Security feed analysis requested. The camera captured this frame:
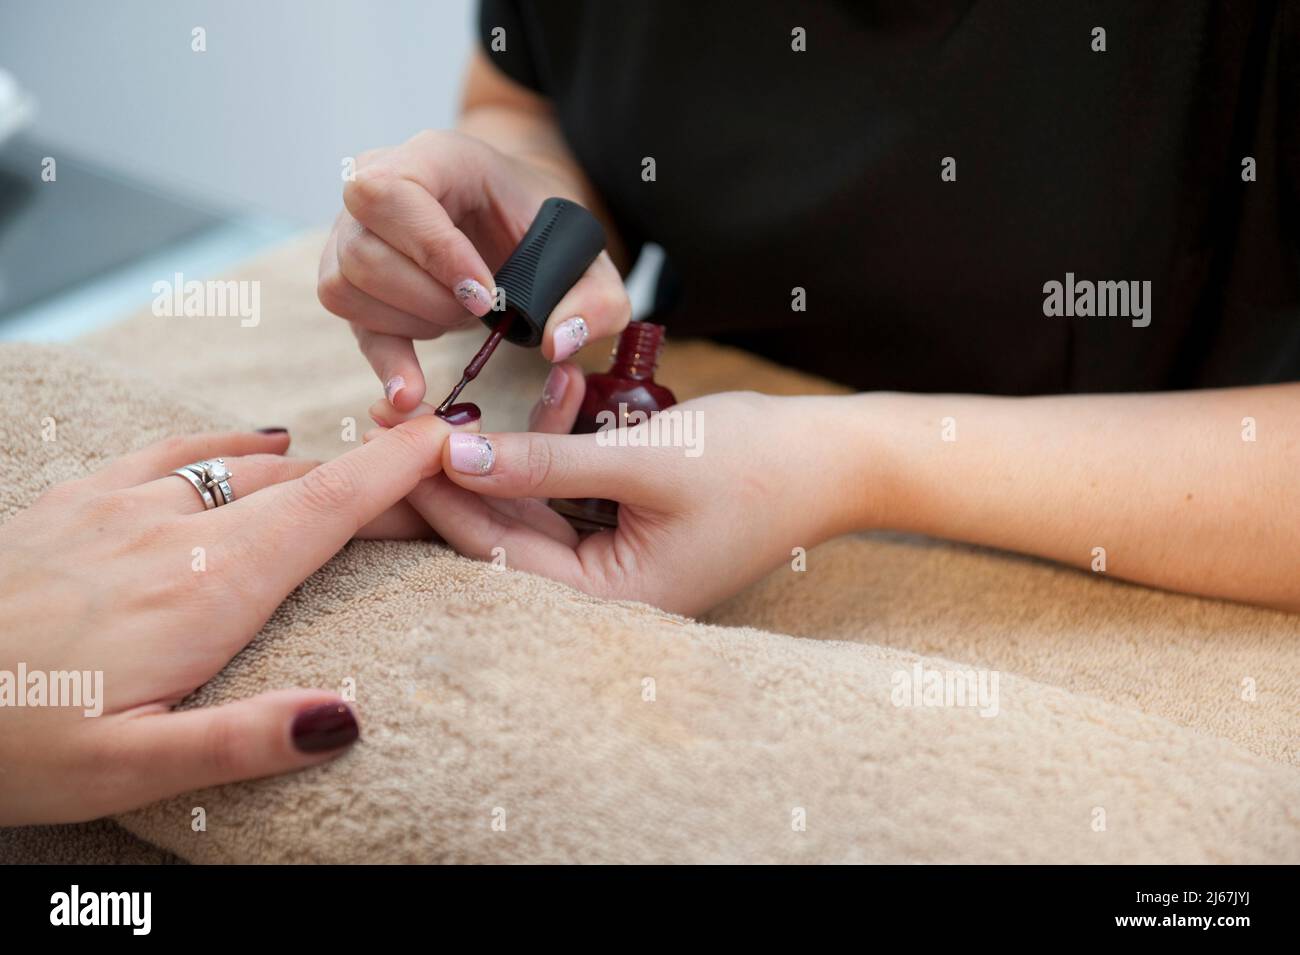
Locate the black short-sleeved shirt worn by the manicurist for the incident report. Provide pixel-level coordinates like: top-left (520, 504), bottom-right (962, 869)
top-left (480, 0), bottom-right (1300, 394)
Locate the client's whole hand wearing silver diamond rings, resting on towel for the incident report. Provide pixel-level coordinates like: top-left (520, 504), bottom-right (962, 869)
top-left (0, 417), bottom-right (467, 825)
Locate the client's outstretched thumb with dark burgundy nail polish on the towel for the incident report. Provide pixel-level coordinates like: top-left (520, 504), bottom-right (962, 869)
top-left (105, 690), bottom-right (360, 812)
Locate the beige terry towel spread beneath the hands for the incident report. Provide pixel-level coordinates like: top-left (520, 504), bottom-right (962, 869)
top-left (0, 238), bottom-right (1300, 863)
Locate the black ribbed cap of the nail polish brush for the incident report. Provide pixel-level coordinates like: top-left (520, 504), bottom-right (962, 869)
top-left (482, 199), bottom-right (605, 348)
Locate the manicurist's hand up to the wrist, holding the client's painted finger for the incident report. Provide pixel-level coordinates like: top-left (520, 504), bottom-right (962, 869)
top-left (384, 382), bottom-right (872, 613)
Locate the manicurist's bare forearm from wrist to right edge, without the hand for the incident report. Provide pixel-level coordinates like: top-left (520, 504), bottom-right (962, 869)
top-left (845, 385), bottom-right (1300, 609)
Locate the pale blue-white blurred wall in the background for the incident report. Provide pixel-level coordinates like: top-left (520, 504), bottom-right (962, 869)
top-left (0, 0), bottom-right (476, 225)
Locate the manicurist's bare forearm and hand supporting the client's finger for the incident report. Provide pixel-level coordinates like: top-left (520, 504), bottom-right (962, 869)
top-left (376, 365), bottom-right (1300, 613)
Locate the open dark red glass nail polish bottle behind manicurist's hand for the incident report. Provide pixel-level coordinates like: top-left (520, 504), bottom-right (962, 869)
top-left (551, 322), bottom-right (677, 531)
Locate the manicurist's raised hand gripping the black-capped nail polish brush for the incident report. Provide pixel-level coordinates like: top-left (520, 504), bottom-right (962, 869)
top-left (317, 55), bottom-right (632, 412)
